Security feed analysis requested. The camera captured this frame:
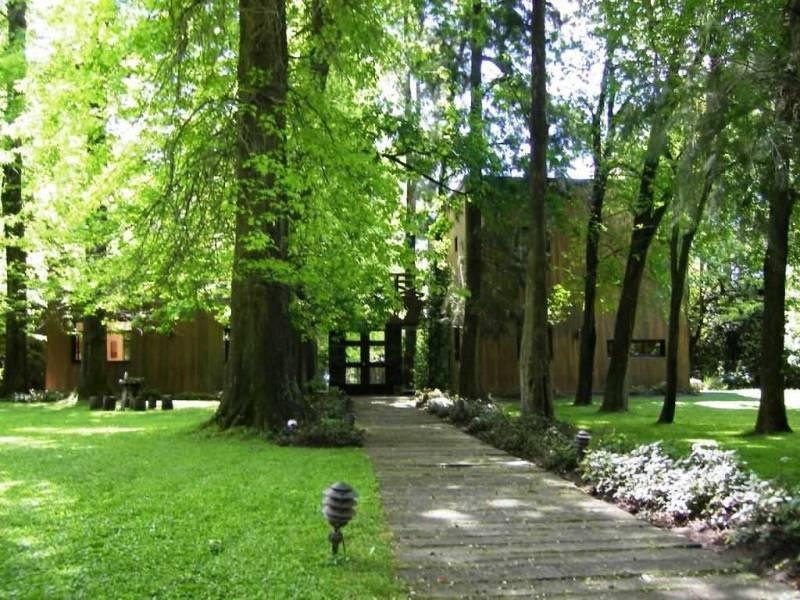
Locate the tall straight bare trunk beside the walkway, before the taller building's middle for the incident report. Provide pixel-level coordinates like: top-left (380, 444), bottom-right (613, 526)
top-left (520, 0), bottom-right (553, 418)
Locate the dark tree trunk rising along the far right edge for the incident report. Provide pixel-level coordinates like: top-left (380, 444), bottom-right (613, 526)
top-left (755, 0), bottom-right (800, 433)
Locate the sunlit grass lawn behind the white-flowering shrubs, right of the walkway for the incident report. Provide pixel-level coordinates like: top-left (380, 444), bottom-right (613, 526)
top-left (555, 392), bottom-right (800, 485)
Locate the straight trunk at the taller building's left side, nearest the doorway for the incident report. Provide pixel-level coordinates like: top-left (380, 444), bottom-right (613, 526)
top-left (458, 2), bottom-right (483, 398)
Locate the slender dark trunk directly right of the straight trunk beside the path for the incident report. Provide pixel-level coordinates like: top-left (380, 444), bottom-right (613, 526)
top-left (575, 56), bottom-right (613, 406)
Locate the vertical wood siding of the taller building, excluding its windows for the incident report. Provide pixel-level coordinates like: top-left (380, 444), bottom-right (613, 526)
top-left (448, 182), bottom-right (689, 396)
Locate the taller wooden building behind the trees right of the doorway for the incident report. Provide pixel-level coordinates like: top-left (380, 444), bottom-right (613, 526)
top-left (449, 178), bottom-right (689, 396)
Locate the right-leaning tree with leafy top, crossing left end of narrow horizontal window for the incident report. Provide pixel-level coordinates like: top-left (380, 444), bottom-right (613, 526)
top-left (601, 0), bottom-right (712, 411)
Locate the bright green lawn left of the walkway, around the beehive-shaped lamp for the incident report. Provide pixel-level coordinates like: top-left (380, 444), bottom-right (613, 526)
top-left (0, 403), bottom-right (404, 599)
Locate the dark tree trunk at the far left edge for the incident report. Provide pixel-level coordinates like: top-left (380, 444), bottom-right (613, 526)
top-left (2, 0), bottom-right (28, 396)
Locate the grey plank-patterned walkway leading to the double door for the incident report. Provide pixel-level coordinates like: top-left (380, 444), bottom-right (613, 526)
top-left (356, 398), bottom-right (800, 600)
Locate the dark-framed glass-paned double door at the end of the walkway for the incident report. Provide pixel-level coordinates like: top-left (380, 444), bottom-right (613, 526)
top-left (329, 330), bottom-right (392, 394)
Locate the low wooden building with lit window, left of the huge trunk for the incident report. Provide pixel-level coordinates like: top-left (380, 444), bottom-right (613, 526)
top-left (45, 312), bottom-right (227, 394)
